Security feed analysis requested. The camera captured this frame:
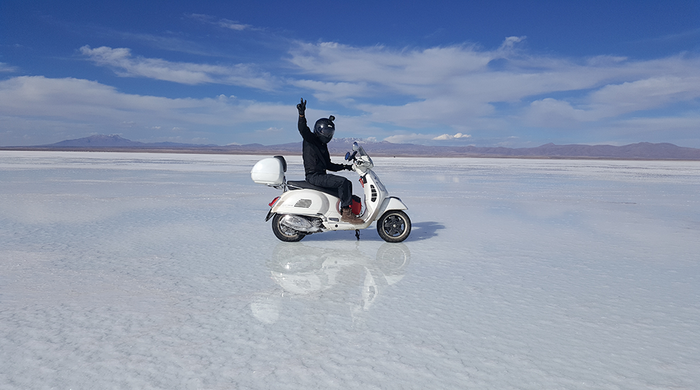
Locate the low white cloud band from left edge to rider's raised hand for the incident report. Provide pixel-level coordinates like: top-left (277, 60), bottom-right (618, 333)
top-left (0, 76), bottom-right (293, 145)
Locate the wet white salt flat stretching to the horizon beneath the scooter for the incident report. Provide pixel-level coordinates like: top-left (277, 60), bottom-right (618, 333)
top-left (0, 152), bottom-right (700, 389)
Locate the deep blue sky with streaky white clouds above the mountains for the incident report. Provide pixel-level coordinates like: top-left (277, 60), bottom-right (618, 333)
top-left (0, 0), bottom-right (700, 148)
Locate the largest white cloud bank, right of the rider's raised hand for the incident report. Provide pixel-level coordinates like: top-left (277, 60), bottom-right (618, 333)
top-left (290, 37), bottom-right (700, 140)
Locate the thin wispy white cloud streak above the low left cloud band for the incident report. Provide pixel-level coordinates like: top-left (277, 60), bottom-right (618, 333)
top-left (80, 46), bottom-right (275, 90)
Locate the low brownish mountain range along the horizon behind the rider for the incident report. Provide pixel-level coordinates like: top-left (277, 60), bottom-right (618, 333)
top-left (0, 135), bottom-right (700, 160)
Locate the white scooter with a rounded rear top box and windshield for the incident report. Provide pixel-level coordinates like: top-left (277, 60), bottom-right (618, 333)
top-left (250, 142), bottom-right (411, 242)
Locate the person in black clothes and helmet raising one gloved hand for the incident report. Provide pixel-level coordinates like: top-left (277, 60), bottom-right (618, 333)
top-left (297, 98), bottom-right (364, 225)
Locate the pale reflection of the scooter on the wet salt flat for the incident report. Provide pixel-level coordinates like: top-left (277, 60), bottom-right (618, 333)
top-left (251, 243), bottom-right (411, 323)
